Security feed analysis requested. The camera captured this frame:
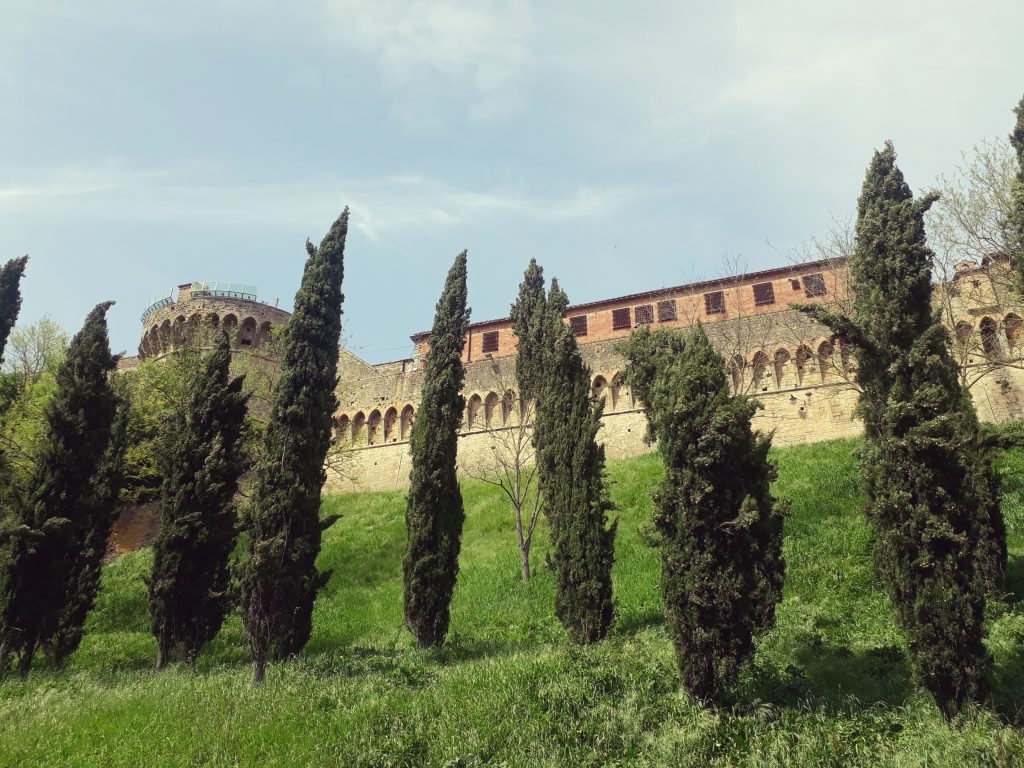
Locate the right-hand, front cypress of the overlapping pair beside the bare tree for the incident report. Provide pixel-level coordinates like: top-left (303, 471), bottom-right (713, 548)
top-left (534, 280), bottom-right (617, 644)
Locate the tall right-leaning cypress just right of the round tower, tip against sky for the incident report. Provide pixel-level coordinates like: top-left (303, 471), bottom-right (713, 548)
top-left (242, 208), bottom-right (348, 682)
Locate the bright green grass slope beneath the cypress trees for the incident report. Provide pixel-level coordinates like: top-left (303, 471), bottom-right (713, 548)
top-left (0, 441), bottom-right (1024, 768)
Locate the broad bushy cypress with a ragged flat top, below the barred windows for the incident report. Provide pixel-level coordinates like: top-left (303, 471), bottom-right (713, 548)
top-left (622, 326), bottom-right (785, 703)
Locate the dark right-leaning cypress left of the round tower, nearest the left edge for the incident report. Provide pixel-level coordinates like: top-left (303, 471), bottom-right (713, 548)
top-left (0, 302), bottom-right (119, 674)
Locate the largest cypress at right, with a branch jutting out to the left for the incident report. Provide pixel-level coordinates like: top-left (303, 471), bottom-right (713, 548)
top-left (803, 142), bottom-right (1006, 717)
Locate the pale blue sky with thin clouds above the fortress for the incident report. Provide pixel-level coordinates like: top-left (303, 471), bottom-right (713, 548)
top-left (0, 0), bottom-right (1024, 362)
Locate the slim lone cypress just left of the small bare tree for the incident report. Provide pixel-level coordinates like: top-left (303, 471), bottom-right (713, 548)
top-left (402, 251), bottom-right (469, 648)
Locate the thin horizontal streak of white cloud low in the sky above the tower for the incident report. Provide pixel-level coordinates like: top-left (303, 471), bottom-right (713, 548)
top-left (0, 161), bottom-right (655, 243)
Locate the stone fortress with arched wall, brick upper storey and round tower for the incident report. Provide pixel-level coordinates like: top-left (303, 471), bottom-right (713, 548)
top-left (130, 259), bottom-right (1024, 492)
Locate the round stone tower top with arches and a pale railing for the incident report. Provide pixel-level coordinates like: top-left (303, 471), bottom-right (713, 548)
top-left (138, 283), bottom-right (291, 359)
